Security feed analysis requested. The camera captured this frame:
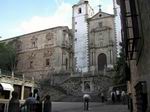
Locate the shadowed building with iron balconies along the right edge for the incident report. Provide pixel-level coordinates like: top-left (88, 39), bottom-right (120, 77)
top-left (117, 0), bottom-right (150, 112)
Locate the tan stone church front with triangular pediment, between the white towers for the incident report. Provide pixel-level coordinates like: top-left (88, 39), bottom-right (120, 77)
top-left (88, 10), bottom-right (117, 72)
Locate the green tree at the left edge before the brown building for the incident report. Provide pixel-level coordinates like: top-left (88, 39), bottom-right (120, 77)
top-left (0, 42), bottom-right (16, 71)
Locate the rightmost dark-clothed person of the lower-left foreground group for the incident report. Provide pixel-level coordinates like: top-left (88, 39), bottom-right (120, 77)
top-left (44, 95), bottom-right (52, 112)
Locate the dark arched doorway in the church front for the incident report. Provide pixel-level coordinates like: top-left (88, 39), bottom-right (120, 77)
top-left (98, 53), bottom-right (107, 71)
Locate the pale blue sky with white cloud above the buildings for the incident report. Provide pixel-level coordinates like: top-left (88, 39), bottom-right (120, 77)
top-left (0, 0), bottom-right (116, 40)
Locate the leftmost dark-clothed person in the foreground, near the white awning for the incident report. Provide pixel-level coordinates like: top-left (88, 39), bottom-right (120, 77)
top-left (8, 91), bottom-right (20, 112)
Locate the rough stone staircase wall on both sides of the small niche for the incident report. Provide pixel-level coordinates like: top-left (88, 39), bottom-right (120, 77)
top-left (60, 75), bottom-right (112, 96)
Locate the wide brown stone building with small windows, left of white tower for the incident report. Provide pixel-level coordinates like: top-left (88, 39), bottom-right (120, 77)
top-left (14, 27), bottom-right (73, 79)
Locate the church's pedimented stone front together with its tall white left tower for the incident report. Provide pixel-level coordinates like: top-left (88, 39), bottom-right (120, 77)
top-left (72, 0), bottom-right (117, 72)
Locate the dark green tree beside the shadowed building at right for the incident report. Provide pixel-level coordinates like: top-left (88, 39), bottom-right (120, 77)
top-left (113, 43), bottom-right (126, 85)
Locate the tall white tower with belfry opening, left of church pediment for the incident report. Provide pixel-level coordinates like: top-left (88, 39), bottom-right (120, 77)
top-left (72, 0), bottom-right (94, 72)
